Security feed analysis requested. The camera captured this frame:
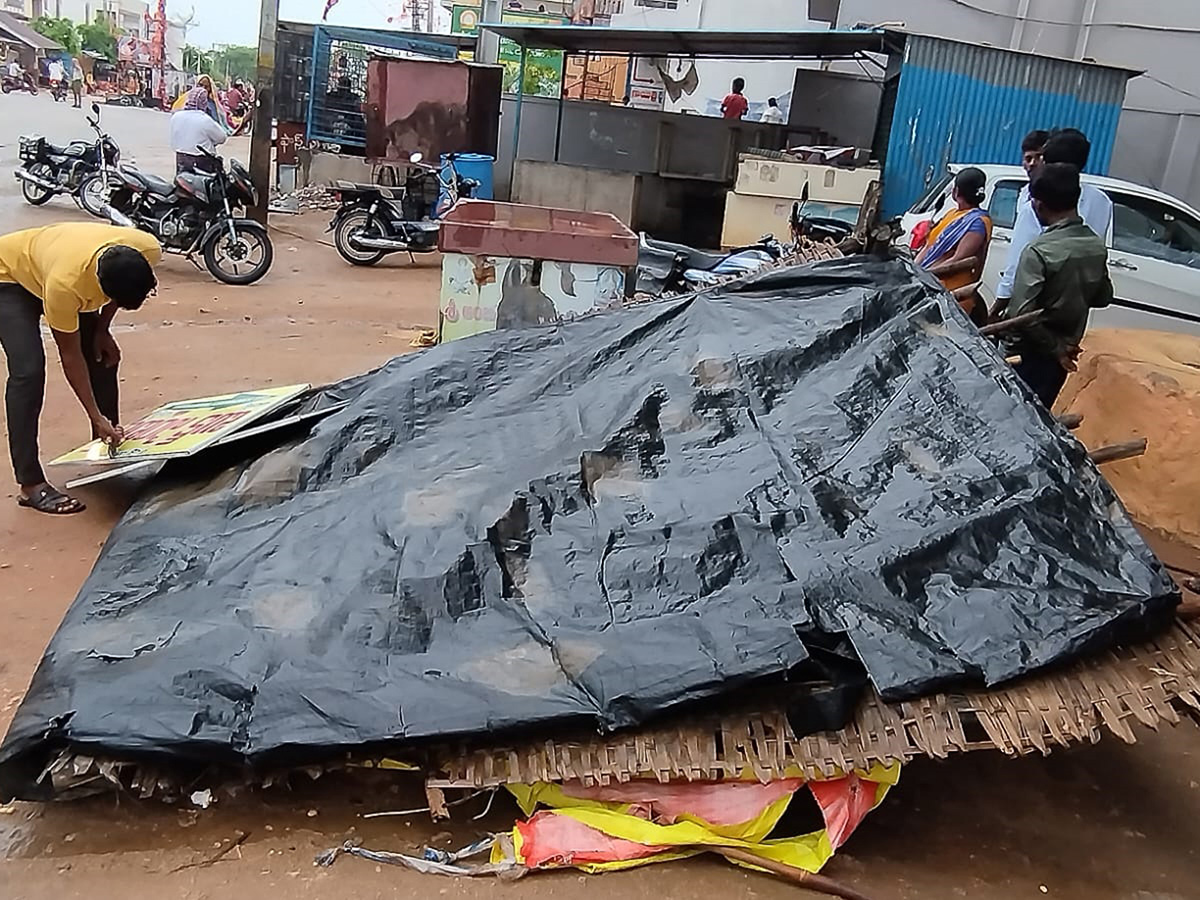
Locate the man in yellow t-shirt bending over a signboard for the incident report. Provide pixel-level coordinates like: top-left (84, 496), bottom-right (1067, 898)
top-left (0, 223), bottom-right (162, 515)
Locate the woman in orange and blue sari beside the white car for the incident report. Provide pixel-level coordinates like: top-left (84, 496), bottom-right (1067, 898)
top-left (917, 169), bottom-right (991, 323)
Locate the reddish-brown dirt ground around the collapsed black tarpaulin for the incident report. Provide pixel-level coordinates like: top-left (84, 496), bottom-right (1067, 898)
top-left (0, 207), bottom-right (1200, 900)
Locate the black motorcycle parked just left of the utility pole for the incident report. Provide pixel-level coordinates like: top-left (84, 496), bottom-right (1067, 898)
top-left (108, 148), bottom-right (275, 284)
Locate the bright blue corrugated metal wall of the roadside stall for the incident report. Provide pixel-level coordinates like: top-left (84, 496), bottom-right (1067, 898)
top-left (883, 35), bottom-right (1128, 216)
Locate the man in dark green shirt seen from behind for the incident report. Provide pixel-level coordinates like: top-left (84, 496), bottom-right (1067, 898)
top-left (1004, 163), bottom-right (1112, 408)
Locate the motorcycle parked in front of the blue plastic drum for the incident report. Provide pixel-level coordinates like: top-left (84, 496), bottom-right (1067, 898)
top-left (325, 154), bottom-right (479, 265)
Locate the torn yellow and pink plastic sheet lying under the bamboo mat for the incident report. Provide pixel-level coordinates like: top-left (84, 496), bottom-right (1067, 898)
top-left (492, 764), bottom-right (900, 872)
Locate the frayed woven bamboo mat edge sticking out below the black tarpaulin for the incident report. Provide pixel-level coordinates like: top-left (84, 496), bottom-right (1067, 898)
top-left (428, 623), bottom-right (1200, 787)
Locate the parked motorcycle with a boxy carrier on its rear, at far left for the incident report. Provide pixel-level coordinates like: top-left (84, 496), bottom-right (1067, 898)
top-left (13, 103), bottom-right (121, 218)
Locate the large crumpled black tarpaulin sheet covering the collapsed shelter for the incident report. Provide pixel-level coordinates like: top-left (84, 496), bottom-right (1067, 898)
top-left (0, 259), bottom-right (1178, 796)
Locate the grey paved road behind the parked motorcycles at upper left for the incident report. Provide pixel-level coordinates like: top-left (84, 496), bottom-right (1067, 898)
top-left (0, 91), bottom-right (250, 230)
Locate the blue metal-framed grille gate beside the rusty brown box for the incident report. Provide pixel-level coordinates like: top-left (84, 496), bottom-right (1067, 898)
top-left (305, 25), bottom-right (458, 150)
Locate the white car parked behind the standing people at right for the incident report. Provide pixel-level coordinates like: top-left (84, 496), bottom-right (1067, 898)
top-left (901, 166), bottom-right (1200, 335)
